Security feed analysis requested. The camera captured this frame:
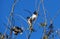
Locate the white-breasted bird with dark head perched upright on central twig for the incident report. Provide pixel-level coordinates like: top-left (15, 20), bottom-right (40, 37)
top-left (27, 11), bottom-right (38, 32)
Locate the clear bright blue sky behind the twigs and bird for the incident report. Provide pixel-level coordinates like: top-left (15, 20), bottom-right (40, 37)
top-left (0, 0), bottom-right (60, 39)
